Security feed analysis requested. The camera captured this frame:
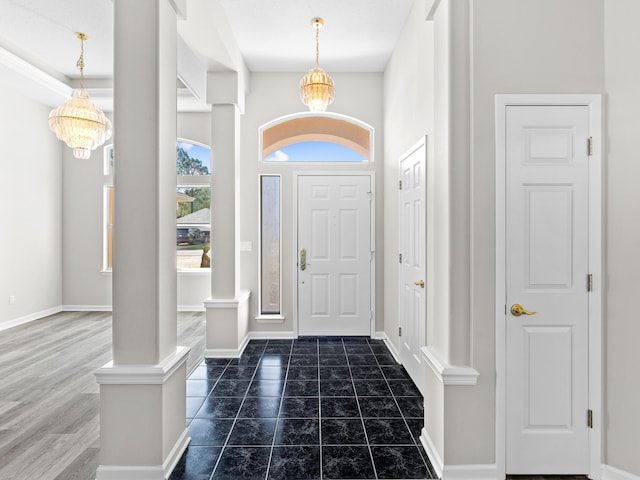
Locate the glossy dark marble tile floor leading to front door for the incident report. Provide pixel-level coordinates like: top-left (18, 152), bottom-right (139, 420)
top-left (170, 337), bottom-right (435, 480)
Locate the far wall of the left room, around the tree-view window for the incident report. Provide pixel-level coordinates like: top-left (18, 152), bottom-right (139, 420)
top-left (62, 113), bottom-right (211, 309)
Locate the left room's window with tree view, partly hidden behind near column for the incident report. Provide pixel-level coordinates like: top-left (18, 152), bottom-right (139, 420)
top-left (104, 140), bottom-right (211, 271)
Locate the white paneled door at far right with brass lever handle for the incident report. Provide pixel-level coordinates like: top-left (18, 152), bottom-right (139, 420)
top-left (505, 105), bottom-right (589, 474)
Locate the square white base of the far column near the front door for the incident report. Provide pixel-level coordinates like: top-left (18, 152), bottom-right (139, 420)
top-left (204, 290), bottom-right (251, 358)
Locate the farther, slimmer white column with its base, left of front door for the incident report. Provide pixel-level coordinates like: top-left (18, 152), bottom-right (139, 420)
top-left (204, 72), bottom-right (250, 357)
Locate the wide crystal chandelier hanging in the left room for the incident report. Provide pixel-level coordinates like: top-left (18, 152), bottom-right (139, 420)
top-left (49, 32), bottom-right (111, 160)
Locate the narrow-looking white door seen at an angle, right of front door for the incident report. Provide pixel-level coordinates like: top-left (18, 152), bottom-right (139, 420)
top-left (399, 141), bottom-right (428, 394)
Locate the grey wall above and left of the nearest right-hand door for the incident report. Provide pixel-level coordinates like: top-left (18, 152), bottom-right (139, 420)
top-left (460, 0), bottom-right (604, 464)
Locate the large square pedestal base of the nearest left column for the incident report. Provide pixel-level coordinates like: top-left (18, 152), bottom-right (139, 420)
top-left (96, 347), bottom-right (191, 480)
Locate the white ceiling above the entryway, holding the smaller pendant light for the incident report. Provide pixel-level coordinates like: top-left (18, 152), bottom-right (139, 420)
top-left (221, 0), bottom-right (413, 72)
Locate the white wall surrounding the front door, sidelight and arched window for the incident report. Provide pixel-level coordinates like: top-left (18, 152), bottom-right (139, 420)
top-left (240, 72), bottom-right (384, 332)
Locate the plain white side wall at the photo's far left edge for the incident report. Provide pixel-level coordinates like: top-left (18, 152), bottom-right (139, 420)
top-left (0, 82), bottom-right (62, 327)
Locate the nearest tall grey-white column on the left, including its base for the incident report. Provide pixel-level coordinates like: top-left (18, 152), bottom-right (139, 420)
top-left (96, 0), bottom-right (190, 480)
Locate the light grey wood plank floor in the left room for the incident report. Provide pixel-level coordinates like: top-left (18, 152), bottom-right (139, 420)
top-left (0, 312), bottom-right (205, 480)
